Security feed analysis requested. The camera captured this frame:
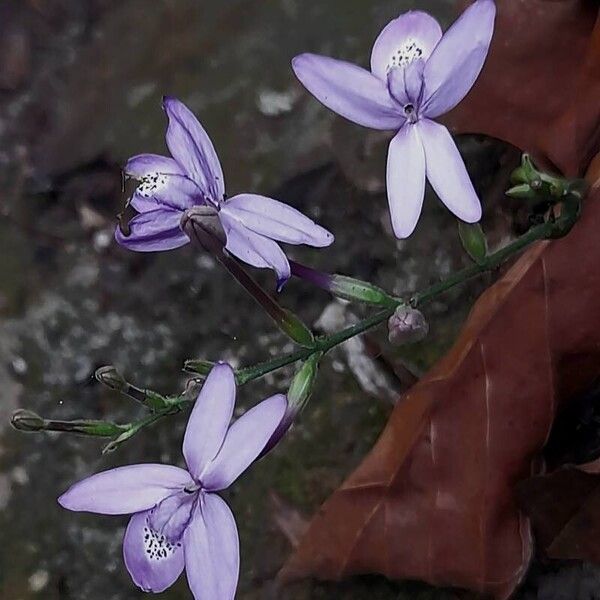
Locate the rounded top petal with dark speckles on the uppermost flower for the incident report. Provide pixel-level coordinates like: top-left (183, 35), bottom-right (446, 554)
top-left (371, 10), bottom-right (442, 81)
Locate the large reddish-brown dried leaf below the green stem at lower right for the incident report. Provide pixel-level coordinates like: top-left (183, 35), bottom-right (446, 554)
top-left (282, 163), bottom-right (600, 598)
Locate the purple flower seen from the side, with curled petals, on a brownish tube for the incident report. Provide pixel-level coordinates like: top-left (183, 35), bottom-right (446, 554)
top-left (115, 97), bottom-right (333, 282)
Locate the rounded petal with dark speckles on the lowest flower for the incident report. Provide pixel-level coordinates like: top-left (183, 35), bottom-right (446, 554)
top-left (123, 511), bottom-right (185, 594)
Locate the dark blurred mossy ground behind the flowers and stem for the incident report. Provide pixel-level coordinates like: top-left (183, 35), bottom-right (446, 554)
top-left (0, 0), bottom-right (598, 600)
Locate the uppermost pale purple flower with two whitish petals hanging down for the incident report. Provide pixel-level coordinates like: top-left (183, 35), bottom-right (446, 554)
top-left (293, 0), bottom-right (496, 238)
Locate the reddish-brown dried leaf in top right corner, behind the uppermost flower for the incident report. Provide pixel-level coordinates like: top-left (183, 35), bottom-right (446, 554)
top-left (446, 0), bottom-right (600, 176)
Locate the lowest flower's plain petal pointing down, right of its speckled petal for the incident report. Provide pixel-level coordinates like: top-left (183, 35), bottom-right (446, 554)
top-left (183, 494), bottom-right (240, 600)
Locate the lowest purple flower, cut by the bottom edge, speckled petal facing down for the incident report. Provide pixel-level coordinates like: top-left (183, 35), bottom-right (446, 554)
top-left (58, 363), bottom-right (287, 600)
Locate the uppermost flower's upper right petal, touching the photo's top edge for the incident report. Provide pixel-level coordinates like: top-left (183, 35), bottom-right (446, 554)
top-left (422, 0), bottom-right (496, 118)
